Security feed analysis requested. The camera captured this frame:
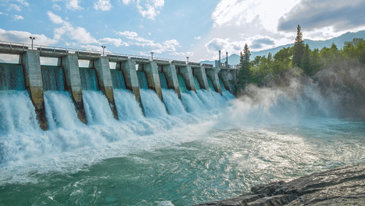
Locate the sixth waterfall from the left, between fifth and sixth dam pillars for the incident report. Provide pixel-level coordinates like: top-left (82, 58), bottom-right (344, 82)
top-left (162, 89), bottom-right (186, 115)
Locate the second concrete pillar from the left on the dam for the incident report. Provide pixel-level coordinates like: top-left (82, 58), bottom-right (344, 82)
top-left (61, 54), bottom-right (87, 124)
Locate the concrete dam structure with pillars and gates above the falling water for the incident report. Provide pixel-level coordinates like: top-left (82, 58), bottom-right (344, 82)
top-left (0, 43), bottom-right (237, 130)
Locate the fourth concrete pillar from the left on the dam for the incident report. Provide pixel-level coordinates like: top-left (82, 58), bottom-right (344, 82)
top-left (116, 59), bottom-right (141, 104)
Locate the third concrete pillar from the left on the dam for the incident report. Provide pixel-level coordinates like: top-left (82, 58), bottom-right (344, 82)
top-left (94, 57), bottom-right (118, 119)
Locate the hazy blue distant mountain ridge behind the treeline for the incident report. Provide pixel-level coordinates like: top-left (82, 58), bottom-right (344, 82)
top-left (201, 30), bottom-right (365, 65)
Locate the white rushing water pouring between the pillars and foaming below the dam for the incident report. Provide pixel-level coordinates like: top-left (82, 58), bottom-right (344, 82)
top-left (0, 89), bottom-right (236, 183)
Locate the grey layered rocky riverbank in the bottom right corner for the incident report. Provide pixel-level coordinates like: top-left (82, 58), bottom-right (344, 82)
top-left (199, 164), bottom-right (365, 206)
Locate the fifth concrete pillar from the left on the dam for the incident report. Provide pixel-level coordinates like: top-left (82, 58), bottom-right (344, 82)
top-left (144, 61), bottom-right (162, 100)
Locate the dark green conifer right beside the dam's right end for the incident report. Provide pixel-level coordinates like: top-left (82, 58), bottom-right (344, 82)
top-left (238, 44), bottom-right (251, 89)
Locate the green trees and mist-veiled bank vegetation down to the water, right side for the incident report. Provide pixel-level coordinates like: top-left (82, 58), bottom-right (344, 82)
top-left (237, 25), bottom-right (365, 118)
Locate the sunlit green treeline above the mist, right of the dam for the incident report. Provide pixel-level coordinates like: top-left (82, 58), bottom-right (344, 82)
top-left (237, 25), bottom-right (365, 92)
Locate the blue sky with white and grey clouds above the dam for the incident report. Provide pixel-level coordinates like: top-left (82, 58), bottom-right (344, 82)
top-left (0, 0), bottom-right (365, 61)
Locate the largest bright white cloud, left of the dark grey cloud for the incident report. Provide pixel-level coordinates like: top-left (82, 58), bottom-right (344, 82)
top-left (194, 0), bottom-right (301, 59)
